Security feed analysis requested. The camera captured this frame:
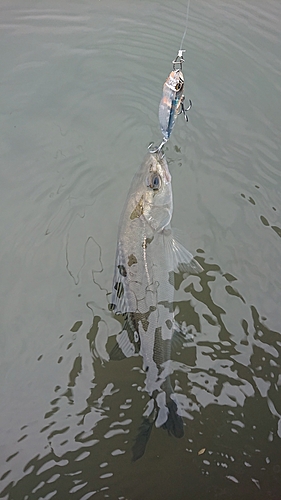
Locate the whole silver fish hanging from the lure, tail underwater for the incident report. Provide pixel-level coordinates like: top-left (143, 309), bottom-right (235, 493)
top-left (110, 151), bottom-right (202, 460)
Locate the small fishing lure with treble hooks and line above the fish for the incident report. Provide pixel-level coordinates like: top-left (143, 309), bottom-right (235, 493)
top-left (148, 0), bottom-right (192, 153)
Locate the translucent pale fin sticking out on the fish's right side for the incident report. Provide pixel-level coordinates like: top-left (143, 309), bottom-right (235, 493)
top-left (167, 232), bottom-right (203, 274)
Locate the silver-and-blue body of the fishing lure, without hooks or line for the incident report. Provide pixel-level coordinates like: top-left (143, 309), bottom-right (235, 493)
top-left (159, 69), bottom-right (184, 140)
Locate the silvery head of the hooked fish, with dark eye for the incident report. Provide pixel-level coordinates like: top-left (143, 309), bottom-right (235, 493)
top-left (131, 151), bottom-right (173, 231)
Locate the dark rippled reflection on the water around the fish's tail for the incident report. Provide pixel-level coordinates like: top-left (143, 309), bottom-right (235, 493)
top-left (1, 249), bottom-right (281, 499)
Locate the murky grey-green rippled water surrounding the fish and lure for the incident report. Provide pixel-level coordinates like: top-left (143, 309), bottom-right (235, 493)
top-left (0, 0), bottom-right (281, 500)
